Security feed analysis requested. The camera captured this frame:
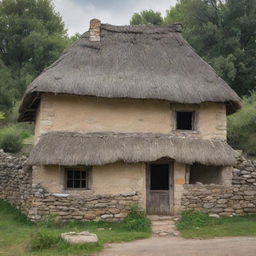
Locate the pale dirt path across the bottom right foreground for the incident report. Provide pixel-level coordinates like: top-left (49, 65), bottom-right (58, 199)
top-left (97, 237), bottom-right (256, 256)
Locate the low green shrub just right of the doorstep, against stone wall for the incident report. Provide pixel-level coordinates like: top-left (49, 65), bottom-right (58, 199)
top-left (177, 210), bottom-right (211, 230)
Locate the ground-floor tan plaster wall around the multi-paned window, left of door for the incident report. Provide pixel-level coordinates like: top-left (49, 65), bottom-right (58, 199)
top-left (32, 162), bottom-right (146, 207)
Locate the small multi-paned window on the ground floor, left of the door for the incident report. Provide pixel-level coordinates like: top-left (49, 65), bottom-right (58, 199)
top-left (65, 167), bottom-right (89, 189)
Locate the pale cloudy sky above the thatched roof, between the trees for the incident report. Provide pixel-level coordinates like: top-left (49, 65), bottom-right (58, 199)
top-left (53, 0), bottom-right (176, 35)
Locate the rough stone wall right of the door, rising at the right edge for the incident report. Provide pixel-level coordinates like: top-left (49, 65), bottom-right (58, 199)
top-left (181, 153), bottom-right (256, 216)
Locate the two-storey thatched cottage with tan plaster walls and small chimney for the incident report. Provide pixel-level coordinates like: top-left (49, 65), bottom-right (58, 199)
top-left (19, 19), bottom-right (241, 219)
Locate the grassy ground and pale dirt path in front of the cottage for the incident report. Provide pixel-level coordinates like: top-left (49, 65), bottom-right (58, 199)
top-left (0, 200), bottom-right (256, 256)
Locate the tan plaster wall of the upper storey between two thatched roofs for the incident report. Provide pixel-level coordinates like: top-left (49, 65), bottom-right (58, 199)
top-left (35, 94), bottom-right (226, 141)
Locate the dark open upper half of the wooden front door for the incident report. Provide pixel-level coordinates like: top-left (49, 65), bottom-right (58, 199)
top-left (150, 164), bottom-right (169, 190)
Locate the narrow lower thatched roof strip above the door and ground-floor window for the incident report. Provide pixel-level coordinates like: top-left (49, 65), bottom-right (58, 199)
top-left (28, 131), bottom-right (235, 166)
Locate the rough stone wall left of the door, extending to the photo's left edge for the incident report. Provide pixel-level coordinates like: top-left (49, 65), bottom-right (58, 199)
top-left (0, 150), bottom-right (142, 221)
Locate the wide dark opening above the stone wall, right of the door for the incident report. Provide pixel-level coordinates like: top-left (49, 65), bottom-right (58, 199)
top-left (189, 164), bottom-right (222, 184)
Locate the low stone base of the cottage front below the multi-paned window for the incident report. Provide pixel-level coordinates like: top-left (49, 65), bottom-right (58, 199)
top-left (28, 186), bottom-right (139, 221)
